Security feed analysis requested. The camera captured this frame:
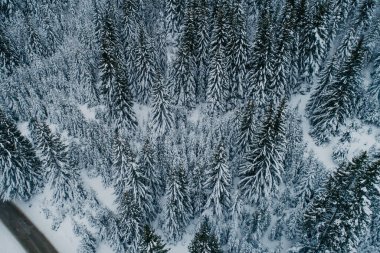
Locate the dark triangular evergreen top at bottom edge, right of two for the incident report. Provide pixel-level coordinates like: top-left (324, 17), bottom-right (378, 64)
top-left (188, 217), bottom-right (222, 253)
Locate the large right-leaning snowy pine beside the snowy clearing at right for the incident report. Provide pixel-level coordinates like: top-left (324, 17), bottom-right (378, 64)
top-left (309, 39), bottom-right (365, 143)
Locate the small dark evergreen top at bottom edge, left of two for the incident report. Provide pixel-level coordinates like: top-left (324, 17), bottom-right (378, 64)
top-left (139, 225), bottom-right (169, 253)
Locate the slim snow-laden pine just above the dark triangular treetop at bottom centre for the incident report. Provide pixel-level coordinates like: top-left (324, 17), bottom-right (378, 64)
top-left (205, 140), bottom-right (232, 219)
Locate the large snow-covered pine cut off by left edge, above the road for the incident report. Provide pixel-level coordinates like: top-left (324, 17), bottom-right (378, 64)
top-left (0, 109), bottom-right (43, 201)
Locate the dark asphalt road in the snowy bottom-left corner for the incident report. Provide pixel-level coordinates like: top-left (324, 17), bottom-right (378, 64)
top-left (0, 201), bottom-right (58, 253)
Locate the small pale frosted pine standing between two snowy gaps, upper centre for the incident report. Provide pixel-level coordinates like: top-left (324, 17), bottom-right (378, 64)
top-left (152, 72), bottom-right (174, 134)
